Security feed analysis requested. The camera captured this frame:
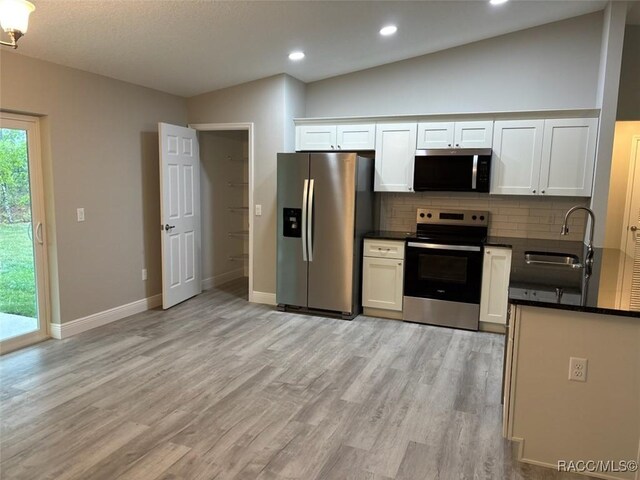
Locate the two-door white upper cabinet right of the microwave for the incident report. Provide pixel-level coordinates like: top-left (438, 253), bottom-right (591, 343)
top-left (491, 118), bottom-right (598, 197)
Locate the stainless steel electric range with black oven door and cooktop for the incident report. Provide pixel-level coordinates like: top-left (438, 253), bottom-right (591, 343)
top-left (403, 208), bottom-right (489, 330)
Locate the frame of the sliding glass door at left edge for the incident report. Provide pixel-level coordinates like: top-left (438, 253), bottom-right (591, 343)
top-left (0, 112), bottom-right (50, 354)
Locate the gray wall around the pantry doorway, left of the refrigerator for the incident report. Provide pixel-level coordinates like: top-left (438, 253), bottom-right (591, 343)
top-left (187, 75), bottom-right (286, 293)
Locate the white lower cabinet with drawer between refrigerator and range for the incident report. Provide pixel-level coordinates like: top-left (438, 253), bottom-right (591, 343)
top-left (362, 240), bottom-right (404, 312)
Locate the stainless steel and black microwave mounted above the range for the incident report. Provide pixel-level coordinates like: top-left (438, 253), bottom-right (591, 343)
top-left (413, 148), bottom-right (491, 192)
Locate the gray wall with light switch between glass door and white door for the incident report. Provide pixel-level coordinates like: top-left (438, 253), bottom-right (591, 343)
top-left (0, 50), bottom-right (187, 323)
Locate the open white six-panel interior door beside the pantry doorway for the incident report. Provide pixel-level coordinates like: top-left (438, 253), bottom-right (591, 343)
top-left (158, 123), bottom-right (202, 309)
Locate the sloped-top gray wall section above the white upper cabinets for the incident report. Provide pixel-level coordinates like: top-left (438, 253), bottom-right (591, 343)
top-left (305, 12), bottom-right (603, 117)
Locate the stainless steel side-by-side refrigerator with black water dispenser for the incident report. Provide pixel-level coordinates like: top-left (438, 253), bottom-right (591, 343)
top-left (276, 153), bottom-right (374, 319)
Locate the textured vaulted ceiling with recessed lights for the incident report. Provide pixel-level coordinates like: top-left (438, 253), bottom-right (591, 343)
top-left (6, 0), bottom-right (605, 96)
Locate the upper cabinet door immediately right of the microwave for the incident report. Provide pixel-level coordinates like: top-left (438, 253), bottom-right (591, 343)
top-left (491, 120), bottom-right (544, 195)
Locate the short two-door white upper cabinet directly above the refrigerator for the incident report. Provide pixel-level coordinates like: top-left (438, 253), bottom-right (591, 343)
top-left (296, 123), bottom-right (376, 151)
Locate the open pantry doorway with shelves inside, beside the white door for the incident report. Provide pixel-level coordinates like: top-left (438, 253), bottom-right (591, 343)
top-left (190, 124), bottom-right (253, 300)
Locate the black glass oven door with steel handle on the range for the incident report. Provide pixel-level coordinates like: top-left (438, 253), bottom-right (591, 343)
top-left (404, 242), bottom-right (482, 304)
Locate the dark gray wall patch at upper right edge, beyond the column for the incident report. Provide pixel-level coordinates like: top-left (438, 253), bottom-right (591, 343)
top-left (617, 25), bottom-right (640, 120)
